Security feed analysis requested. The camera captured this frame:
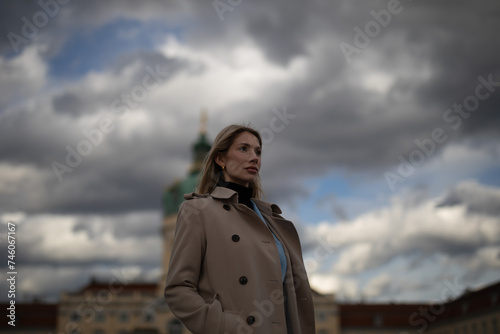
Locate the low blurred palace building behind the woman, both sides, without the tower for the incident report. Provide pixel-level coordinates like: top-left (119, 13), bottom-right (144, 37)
top-left (4, 281), bottom-right (500, 334)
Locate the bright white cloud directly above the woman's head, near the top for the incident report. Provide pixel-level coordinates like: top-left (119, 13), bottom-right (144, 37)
top-left (155, 37), bottom-right (305, 113)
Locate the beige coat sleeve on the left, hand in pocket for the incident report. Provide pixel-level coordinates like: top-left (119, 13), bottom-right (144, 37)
top-left (165, 199), bottom-right (224, 334)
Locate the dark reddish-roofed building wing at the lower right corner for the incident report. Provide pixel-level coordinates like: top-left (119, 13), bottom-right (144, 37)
top-left (339, 282), bottom-right (500, 334)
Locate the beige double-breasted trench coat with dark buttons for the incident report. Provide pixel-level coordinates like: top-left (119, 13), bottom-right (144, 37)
top-left (165, 187), bottom-right (315, 334)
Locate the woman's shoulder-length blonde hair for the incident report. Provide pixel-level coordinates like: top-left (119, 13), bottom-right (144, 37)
top-left (196, 124), bottom-right (263, 199)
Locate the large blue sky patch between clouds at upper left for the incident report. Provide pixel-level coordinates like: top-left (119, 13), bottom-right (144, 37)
top-left (49, 19), bottom-right (183, 78)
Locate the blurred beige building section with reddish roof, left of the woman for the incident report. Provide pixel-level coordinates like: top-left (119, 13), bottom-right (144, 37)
top-left (57, 276), bottom-right (182, 334)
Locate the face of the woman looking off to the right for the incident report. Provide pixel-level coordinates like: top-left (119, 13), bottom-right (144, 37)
top-left (215, 131), bottom-right (262, 187)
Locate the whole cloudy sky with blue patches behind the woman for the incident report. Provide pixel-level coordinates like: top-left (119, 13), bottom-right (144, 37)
top-left (0, 0), bottom-right (500, 301)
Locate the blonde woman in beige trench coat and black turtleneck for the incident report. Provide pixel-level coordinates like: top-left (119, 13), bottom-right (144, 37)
top-left (165, 125), bottom-right (315, 334)
